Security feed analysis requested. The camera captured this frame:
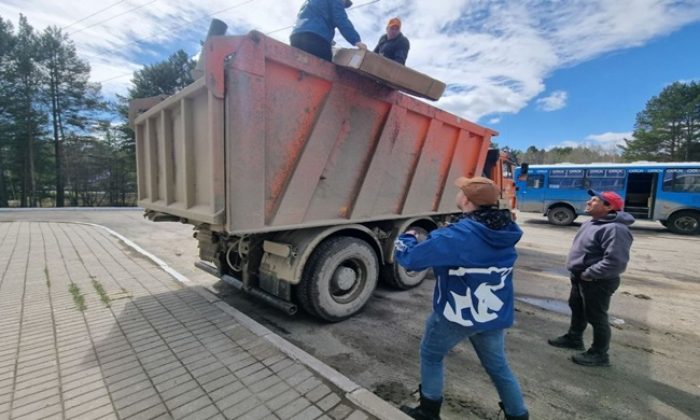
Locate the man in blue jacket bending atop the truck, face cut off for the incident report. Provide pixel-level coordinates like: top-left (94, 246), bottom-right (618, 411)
top-left (289, 0), bottom-right (367, 61)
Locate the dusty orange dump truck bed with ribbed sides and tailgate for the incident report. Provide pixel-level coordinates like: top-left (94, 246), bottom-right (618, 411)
top-left (135, 32), bottom-right (496, 234)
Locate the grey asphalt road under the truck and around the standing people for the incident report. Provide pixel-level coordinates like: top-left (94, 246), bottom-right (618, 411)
top-left (0, 211), bottom-right (700, 420)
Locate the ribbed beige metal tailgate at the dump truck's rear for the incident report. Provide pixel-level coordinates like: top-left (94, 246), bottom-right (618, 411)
top-left (134, 79), bottom-right (225, 225)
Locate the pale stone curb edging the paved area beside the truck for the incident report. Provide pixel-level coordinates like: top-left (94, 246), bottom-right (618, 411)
top-left (92, 222), bottom-right (410, 420)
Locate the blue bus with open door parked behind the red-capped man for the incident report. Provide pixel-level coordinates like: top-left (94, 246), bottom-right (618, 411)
top-left (514, 162), bottom-right (700, 235)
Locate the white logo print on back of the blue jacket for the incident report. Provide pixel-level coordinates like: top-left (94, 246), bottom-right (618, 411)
top-left (443, 267), bottom-right (513, 327)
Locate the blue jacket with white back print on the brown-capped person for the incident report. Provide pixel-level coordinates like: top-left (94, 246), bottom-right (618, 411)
top-left (395, 217), bottom-right (523, 331)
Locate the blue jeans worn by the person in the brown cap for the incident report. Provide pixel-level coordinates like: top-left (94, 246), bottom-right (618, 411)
top-left (420, 312), bottom-right (527, 416)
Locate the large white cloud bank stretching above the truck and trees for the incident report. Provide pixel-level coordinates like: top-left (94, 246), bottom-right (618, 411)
top-left (0, 0), bottom-right (700, 120)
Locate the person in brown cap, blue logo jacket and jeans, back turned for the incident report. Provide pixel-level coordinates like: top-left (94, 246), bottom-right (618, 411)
top-left (395, 177), bottom-right (529, 420)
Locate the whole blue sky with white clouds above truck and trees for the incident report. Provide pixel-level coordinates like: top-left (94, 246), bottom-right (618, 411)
top-left (0, 0), bottom-right (700, 150)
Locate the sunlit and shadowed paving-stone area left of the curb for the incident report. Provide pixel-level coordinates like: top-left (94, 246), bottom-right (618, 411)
top-left (0, 222), bottom-right (373, 420)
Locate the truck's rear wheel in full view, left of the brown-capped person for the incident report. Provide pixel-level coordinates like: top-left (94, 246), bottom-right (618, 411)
top-left (297, 237), bottom-right (379, 322)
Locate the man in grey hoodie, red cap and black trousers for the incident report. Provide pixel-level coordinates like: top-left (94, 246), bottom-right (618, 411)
top-left (548, 190), bottom-right (634, 366)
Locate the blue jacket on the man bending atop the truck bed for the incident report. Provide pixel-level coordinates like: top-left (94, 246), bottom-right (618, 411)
top-left (292, 0), bottom-right (361, 45)
